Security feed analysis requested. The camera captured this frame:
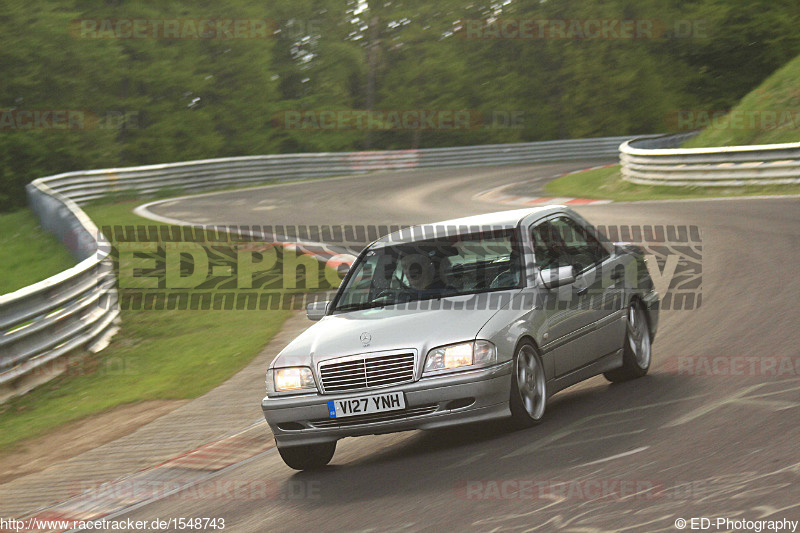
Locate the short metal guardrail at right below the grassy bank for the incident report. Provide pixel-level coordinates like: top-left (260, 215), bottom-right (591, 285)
top-left (619, 132), bottom-right (800, 187)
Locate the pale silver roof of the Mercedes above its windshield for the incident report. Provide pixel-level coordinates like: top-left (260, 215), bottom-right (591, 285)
top-left (372, 205), bottom-right (567, 247)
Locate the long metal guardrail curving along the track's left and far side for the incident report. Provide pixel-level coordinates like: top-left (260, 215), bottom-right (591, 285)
top-left (0, 137), bottom-right (644, 402)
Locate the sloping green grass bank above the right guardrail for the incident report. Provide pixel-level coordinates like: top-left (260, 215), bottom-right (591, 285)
top-left (684, 56), bottom-right (800, 148)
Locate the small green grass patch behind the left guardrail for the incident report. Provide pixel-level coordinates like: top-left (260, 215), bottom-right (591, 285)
top-left (0, 209), bottom-right (75, 294)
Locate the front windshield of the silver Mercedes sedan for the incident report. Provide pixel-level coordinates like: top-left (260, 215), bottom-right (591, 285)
top-left (334, 229), bottom-right (522, 311)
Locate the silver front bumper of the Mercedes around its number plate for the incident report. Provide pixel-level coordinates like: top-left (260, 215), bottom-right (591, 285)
top-left (261, 361), bottom-right (512, 446)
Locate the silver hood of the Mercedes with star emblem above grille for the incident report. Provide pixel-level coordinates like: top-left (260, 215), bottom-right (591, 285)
top-left (273, 289), bottom-right (519, 366)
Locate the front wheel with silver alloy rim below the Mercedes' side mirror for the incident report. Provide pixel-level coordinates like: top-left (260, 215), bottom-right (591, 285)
top-left (509, 341), bottom-right (547, 428)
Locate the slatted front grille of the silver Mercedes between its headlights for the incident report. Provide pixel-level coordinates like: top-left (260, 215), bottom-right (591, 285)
top-left (319, 353), bottom-right (414, 392)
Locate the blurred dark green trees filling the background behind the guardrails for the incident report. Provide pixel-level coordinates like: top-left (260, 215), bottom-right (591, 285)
top-left (0, 0), bottom-right (800, 211)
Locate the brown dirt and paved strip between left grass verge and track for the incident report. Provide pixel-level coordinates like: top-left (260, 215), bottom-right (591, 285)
top-left (0, 313), bottom-right (308, 520)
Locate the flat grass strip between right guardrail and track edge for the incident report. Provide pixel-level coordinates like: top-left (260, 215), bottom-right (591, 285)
top-left (545, 165), bottom-right (800, 202)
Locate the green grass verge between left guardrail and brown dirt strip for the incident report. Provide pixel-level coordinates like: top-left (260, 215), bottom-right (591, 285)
top-left (0, 201), bottom-right (340, 452)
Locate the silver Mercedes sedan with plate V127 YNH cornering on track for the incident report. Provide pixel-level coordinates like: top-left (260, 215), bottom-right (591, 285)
top-left (261, 206), bottom-right (659, 470)
